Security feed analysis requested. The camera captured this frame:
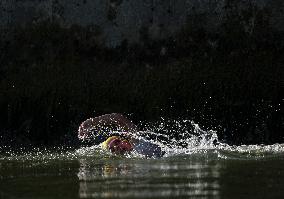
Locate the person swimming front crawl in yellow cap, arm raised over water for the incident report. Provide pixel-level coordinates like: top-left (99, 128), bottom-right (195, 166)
top-left (78, 113), bottom-right (164, 157)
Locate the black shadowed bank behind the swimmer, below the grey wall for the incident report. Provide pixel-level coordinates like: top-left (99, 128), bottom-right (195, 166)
top-left (0, 8), bottom-right (284, 145)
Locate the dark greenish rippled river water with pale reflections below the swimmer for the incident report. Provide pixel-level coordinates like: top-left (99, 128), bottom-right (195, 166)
top-left (0, 120), bottom-right (284, 199)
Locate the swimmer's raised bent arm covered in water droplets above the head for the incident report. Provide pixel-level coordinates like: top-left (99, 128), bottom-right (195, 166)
top-left (78, 113), bottom-right (137, 139)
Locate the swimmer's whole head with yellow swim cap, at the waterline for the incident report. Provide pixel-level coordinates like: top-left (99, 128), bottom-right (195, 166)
top-left (103, 136), bottom-right (133, 155)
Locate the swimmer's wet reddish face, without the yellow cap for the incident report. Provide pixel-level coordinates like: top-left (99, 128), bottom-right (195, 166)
top-left (108, 138), bottom-right (133, 154)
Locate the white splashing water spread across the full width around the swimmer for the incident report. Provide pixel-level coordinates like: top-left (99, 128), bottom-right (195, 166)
top-left (0, 119), bottom-right (284, 161)
